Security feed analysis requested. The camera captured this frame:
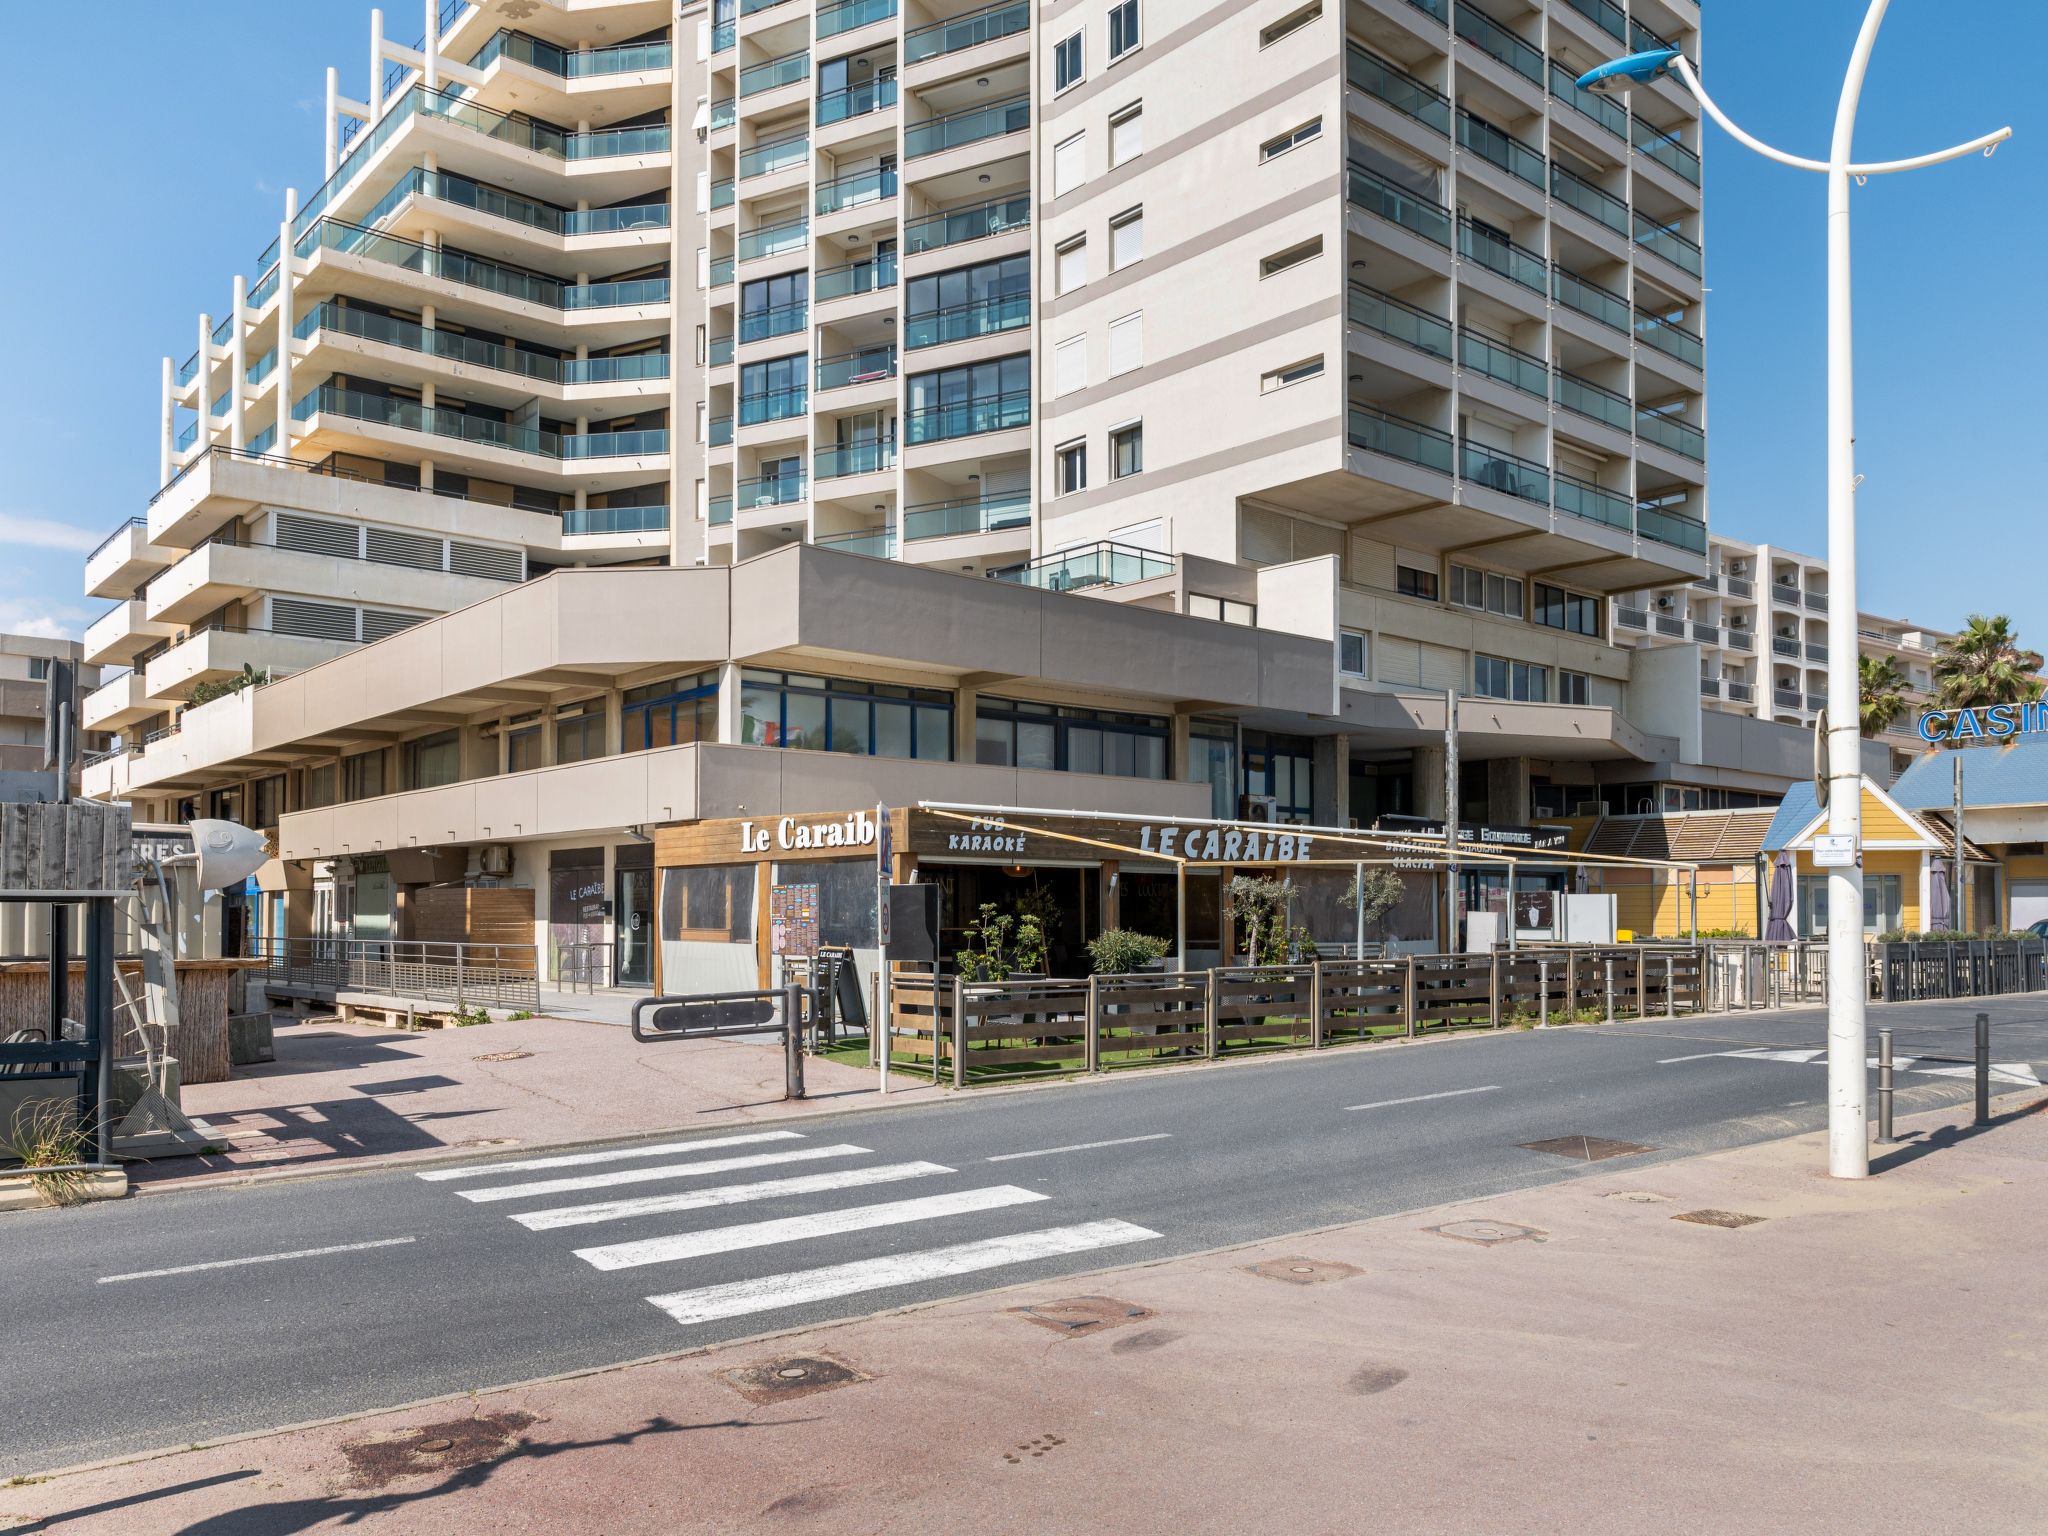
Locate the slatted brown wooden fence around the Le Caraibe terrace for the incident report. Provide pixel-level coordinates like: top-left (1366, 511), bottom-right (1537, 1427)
top-left (888, 944), bottom-right (1706, 1087)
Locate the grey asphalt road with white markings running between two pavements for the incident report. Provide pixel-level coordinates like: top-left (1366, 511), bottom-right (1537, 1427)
top-left (0, 997), bottom-right (2048, 1477)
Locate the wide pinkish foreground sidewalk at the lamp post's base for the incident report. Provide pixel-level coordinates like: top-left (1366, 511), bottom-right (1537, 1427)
top-left (19, 1096), bottom-right (2048, 1536)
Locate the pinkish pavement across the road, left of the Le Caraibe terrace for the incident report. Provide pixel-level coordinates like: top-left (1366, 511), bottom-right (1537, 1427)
top-left (129, 1016), bottom-right (938, 1188)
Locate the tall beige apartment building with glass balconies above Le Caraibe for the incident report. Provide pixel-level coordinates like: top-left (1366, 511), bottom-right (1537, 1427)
top-left (88, 0), bottom-right (1900, 983)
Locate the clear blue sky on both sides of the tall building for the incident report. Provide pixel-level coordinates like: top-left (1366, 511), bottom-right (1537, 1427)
top-left (0, 0), bottom-right (2048, 647)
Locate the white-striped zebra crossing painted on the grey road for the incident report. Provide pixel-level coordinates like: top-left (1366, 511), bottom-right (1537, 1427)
top-left (418, 1130), bottom-right (1163, 1325)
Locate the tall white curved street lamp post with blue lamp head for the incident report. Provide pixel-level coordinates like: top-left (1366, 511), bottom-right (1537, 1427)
top-left (1579, 0), bottom-right (2013, 1180)
